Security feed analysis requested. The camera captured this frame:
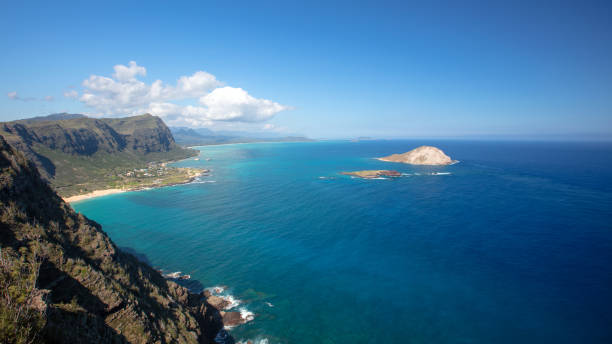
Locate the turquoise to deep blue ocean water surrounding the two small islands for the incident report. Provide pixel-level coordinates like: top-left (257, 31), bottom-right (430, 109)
top-left (74, 141), bottom-right (612, 344)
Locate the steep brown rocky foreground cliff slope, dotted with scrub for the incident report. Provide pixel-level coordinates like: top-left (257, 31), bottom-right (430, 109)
top-left (0, 136), bottom-right (223, 343)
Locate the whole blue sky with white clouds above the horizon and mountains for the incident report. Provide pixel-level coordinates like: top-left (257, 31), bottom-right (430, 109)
top-left (0, 1), bottom-right (612, 138)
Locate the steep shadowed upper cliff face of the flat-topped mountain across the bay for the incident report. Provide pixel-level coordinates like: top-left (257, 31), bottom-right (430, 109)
top-left (0, 114), bottom-right (194, 179)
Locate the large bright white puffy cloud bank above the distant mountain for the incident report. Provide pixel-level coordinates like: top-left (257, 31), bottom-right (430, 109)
top-left (76, 61), bottom-right (289, 126)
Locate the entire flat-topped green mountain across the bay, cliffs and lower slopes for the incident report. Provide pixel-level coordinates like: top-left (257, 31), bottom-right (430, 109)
top-left (0, 114), bottom-right (197, 196)
